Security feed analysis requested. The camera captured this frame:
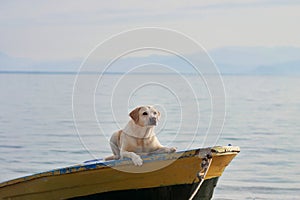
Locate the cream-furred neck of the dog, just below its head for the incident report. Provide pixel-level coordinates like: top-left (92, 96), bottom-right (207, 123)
top-left (123, 120), bottom-right (155, 139)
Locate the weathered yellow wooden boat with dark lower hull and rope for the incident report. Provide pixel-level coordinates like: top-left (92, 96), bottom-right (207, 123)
top-left (0, 146), bottom-right (240, 200)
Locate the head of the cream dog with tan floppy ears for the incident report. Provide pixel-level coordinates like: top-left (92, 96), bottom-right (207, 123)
top-left (129, 106), bottom-right (160, 127)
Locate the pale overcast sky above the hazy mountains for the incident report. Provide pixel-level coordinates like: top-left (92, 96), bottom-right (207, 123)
top-left (0, 0), bottom-right (300, 61)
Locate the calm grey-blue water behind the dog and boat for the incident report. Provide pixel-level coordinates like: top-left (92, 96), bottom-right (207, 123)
top-left (0, 74), bottom-right (300, 200)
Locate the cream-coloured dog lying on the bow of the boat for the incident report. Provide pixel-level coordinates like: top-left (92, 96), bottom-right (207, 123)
top-left (105, 106), bottom-right (176, 166)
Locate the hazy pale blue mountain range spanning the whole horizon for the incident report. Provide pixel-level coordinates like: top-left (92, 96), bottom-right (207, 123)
top-left (0, 47), bottom-right (300, 75)
